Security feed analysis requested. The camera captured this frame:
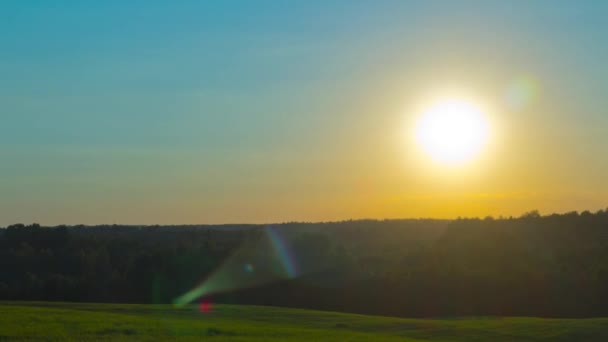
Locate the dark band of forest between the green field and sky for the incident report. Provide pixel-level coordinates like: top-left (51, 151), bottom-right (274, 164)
top-left (0, 210), bottom-right (608, 317)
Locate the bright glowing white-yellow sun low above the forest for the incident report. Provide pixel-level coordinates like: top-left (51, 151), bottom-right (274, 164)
top-left (415, 98), bottom-right (489, 164)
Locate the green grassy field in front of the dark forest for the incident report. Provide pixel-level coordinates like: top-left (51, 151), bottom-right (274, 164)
top-left (0, 302), bottom-right (608, 341)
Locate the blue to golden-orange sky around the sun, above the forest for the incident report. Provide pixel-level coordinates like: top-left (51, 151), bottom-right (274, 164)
top-left (0, 0), bottom-right (608, 225)
